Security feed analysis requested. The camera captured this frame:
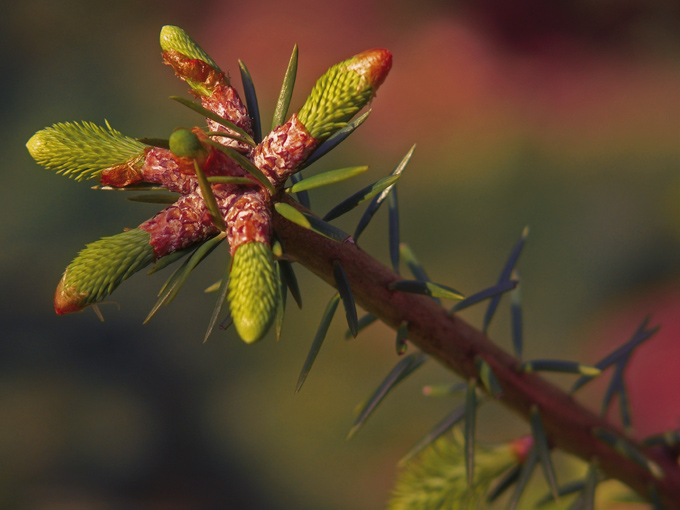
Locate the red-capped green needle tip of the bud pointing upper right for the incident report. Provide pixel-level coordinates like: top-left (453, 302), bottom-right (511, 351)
top-left (298, 48), bottom-right (392, 140)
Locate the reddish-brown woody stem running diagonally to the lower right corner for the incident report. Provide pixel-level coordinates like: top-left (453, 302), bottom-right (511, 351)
top-left (275, 205), bottom-right (680, 510)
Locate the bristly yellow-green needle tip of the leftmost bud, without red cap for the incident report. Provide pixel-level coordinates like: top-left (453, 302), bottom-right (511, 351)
top-left (26, 122), bottom-right (147, 181)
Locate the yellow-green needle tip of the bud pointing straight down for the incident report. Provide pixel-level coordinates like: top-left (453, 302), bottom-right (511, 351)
top-left (228, 242), bottom-right (279, 344)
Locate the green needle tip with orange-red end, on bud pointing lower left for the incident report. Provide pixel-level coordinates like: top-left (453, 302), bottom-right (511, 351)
top-left (54, 229), bottom-right (155, 315)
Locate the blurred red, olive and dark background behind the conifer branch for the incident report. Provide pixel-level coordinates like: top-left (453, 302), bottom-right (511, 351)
top-left (0, 0), bottom-right (680, 510)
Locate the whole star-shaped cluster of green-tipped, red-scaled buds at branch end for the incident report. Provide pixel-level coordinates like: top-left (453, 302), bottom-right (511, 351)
top-left (27, 26), bottom-right (392, 343)
